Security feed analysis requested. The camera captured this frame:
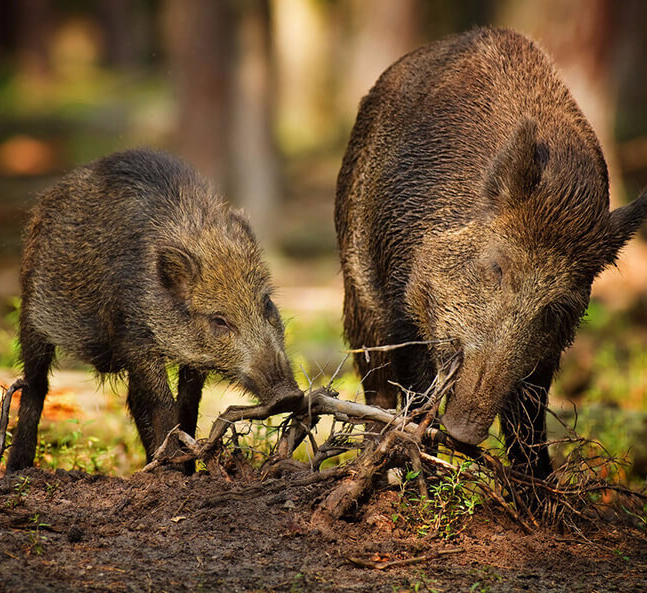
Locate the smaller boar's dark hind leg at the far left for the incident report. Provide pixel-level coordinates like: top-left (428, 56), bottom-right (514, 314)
top-left (7, 324), bottom-right (54, 472)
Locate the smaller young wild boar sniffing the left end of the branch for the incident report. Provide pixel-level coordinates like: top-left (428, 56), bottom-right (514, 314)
top-left (7, 150), bottom-right (302, 471)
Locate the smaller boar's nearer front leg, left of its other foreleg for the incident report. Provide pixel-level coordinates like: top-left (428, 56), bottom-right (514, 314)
top-left (126, 362), bottom-right (177, 463)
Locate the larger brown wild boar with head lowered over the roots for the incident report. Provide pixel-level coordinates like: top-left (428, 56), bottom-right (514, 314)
top-left (335, 28), bottom-right (647, 476)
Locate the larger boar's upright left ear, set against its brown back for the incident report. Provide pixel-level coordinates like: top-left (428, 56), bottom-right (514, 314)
top-left (485, 119), bottom-right (547, 209)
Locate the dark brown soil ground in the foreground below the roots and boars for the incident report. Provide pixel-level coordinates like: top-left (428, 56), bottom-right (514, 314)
top-left (0, 469), bottom-right (647, 593)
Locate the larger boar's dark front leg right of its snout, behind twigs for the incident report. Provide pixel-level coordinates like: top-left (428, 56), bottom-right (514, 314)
top-left (500, 360), bottom-right (554, 478)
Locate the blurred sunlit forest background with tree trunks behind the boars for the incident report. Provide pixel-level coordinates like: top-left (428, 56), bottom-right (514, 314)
top-left (0, 0), bottom-right (647, 477)
